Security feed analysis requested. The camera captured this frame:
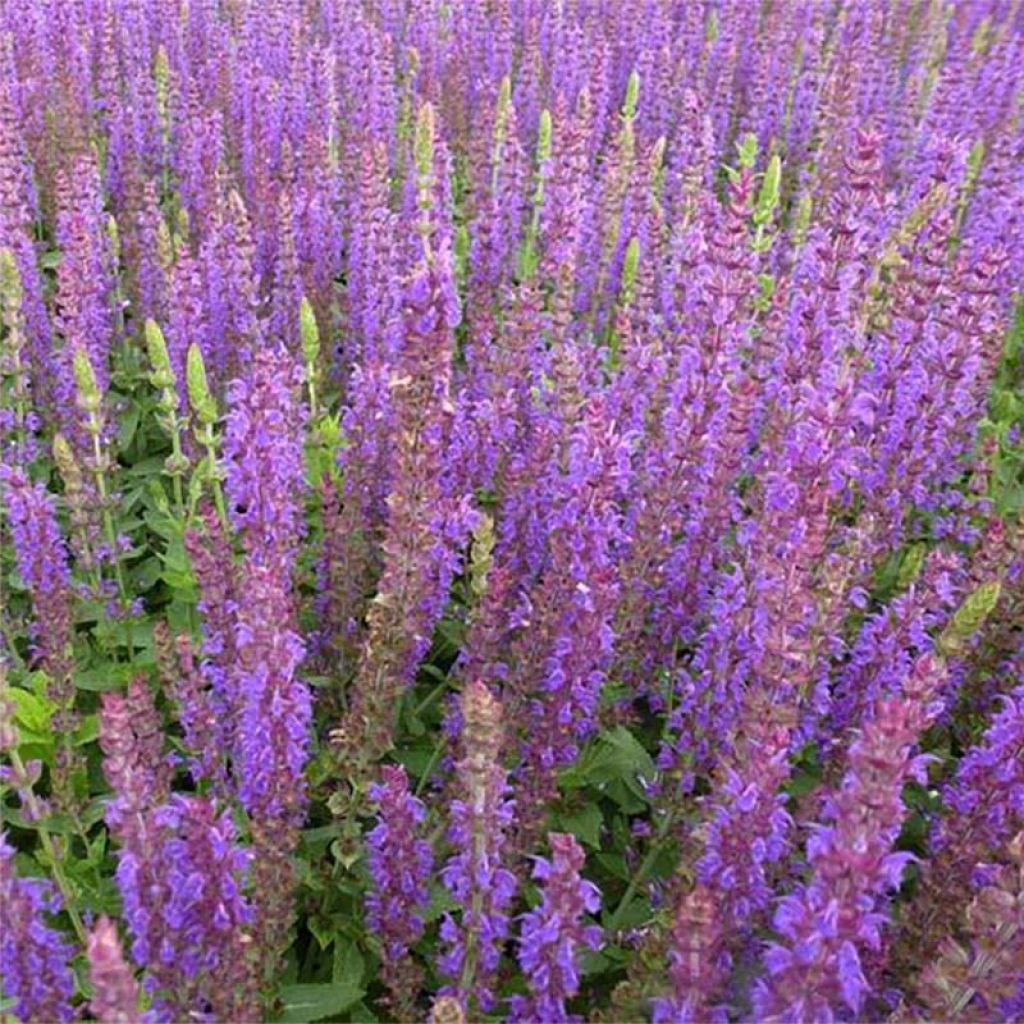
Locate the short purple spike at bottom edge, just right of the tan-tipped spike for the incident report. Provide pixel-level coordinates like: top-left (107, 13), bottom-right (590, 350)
top-left (510, 833), bottom-right (601, 1022)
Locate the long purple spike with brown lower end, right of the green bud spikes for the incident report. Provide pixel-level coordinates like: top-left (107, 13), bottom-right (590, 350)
top-left (223, 347), bottom-right (312, 997)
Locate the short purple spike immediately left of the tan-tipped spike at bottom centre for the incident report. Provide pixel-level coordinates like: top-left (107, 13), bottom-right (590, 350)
top-left (367, 765), bottom-right (434, 1019)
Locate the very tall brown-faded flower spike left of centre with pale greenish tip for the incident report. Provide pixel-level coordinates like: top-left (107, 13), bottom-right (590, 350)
top-left (342, 103), bottom-right (472, 760)
